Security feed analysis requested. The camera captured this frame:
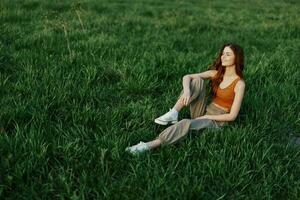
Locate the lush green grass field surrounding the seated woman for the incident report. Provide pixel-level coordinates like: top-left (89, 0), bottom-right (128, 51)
top-left (0, 0), bottom-right (300, 200)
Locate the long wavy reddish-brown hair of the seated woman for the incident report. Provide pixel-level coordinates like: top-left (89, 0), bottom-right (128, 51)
top-left (209, 43), bottom-right (244, 97)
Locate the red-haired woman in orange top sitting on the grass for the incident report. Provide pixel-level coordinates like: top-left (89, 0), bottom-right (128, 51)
top-left (126, 43), bottom-right (245, 154)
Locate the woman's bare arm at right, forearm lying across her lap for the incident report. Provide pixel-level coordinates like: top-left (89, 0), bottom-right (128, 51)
top-left (197, 80), bottom-right (245, 121)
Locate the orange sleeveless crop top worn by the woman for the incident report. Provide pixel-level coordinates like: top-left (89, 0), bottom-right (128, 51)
top-left (213, 77), bottom-right (241, 111)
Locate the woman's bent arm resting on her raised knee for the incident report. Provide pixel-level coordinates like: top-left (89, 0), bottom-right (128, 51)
top-left (181, 70), bottom-right (218, 105)
